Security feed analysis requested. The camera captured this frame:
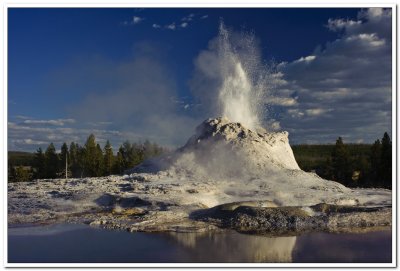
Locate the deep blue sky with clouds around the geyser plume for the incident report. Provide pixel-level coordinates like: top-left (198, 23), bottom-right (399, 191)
top-left (8, 8), bottom-right (392, 151)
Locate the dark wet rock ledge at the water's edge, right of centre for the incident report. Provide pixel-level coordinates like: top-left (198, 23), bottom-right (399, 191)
top-left (192, 202), bottom-right (392, 235)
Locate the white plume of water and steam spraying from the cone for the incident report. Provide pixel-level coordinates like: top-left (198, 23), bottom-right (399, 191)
top-left (192, 22), bottom-right (273, 130)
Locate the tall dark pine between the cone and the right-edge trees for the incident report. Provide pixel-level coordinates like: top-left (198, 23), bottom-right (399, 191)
top-left (332, 137), bottom-right (352, 184)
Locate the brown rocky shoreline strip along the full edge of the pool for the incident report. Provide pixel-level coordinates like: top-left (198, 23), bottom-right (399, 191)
top-left (8, 202), bottom-right (392, 237)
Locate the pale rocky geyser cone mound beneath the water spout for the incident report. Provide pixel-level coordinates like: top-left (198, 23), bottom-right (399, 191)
top-left (133, 118), bottom-right (299, 178)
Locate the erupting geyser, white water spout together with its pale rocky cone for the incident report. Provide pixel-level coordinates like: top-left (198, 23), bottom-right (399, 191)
top-left (134, 22), bottom-right (300, 179)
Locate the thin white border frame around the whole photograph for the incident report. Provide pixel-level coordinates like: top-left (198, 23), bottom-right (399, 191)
top-left (0, 0), bottom-right (399, 268)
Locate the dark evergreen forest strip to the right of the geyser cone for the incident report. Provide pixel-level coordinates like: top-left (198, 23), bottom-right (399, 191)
top-left (293, 133), bottom-right (392, 189)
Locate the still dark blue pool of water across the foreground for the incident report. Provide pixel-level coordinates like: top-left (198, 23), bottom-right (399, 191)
top-left (8, 224), bottom-right (392, 263)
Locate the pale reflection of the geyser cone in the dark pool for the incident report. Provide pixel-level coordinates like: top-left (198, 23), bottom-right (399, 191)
top-left (168, 231), bottom-right (296, 263)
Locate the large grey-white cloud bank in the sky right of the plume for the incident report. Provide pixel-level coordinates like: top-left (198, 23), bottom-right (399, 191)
top-left (278, 8), bottom-right (392, 143)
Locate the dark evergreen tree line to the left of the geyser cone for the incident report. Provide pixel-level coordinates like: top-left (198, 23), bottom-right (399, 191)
top-left (8, 134), bottom-right (167, 182)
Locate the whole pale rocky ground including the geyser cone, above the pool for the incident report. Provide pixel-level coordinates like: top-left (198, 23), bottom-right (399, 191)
top-left (8, 118), bottom-right (392, 234)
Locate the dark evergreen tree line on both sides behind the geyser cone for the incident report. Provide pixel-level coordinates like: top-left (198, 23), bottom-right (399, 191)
top-left (8, 133), bottom-right (392, 189)
